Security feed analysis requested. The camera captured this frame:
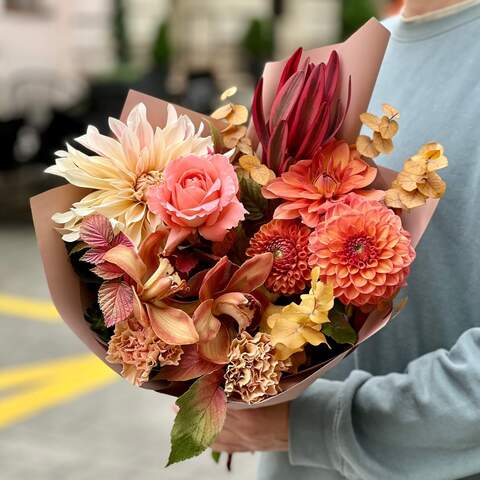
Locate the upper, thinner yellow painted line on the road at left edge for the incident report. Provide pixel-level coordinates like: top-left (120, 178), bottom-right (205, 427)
top-left (0, 293), bottom-right (60, 323)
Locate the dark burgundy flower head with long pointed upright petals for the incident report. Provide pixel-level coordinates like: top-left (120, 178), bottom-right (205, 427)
top-left (252, 48), bottom-right (350, 175)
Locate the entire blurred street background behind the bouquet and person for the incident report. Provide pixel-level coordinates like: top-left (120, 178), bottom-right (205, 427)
top-left (0, 0), bottom-right (402, 480)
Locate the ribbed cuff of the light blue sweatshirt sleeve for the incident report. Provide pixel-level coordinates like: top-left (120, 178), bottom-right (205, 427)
top-left (289, 380), bottom-right (344, 470)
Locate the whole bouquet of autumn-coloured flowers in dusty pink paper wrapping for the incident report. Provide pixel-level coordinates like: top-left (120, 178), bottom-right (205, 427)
top-left (32, 21), bottom-right (447, 464)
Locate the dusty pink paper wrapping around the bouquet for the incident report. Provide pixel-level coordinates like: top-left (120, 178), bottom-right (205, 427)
top-left (31, 19), bottom-right (437, 409)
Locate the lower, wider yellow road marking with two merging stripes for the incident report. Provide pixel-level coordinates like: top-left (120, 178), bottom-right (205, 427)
top-left (0, 354), bottom-right (119, 428)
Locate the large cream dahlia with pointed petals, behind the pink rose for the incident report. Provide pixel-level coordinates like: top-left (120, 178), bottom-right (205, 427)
top-left (46, 103), bottom-right (212, 246)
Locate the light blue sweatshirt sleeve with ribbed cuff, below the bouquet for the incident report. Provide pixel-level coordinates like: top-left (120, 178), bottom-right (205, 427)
top-left (289, 328), bottom-right (480, 480)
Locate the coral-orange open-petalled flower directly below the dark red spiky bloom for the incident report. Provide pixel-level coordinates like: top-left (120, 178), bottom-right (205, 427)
top-left (262, 141), bottom-right (383, 228)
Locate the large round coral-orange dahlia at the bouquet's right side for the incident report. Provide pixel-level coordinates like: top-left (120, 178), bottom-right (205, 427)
top-left (309, 194), bottom-right (415, 306)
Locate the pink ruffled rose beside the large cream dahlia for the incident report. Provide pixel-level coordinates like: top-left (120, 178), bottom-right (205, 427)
top-left (147, 155), bottom-right (247, 253)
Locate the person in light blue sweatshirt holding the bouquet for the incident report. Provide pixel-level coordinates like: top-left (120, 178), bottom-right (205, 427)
top-left (215, 0), bottom-right (480, 480)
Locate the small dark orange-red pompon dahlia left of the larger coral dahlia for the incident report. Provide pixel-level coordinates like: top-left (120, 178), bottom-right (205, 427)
top-left (246, 220), bottom-right (311, 295)
